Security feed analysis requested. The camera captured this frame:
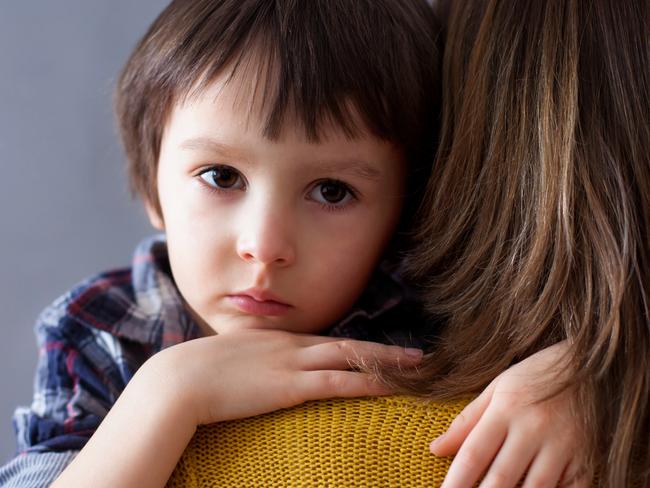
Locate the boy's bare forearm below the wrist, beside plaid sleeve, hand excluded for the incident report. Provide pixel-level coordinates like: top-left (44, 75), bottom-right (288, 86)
top-left (52, 354), bottom-right (196, 488)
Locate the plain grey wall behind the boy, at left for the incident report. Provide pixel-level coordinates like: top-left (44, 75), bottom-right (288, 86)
top-left (0, 0), bottom-right (167, 463)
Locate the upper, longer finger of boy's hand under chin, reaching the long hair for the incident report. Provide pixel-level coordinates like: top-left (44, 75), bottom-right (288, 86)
top-left (299, 340), bottom-right (422, 371)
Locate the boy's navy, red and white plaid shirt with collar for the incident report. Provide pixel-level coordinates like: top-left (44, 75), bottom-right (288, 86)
top-left (0, 236), bottom-right (421, 486)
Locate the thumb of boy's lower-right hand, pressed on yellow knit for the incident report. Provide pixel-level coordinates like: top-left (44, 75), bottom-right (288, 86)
top-left (430, 381), bottom-right (495, 456)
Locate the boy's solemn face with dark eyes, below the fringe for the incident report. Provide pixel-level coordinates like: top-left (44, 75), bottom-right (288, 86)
top-left (148, 80), bottom-right (406, 334)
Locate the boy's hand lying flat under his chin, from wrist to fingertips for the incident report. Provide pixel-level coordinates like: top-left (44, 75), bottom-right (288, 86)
top-left (145, 330), bottom-right (421, 425)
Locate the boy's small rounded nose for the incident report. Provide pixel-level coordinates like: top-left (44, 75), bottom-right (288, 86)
top-left (237, 206), bottom-right (296, 267)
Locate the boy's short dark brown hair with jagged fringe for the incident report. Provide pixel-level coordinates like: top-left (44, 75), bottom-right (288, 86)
top-left (115, 0), bottom-right (439, 215)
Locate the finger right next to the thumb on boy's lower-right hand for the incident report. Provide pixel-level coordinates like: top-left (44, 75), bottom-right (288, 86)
top-left (442, 410), bottom-right (507, 488)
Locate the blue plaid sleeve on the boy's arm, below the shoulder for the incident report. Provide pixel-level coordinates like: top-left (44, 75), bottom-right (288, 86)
top-left (0, 301), bottom-right (123, 472)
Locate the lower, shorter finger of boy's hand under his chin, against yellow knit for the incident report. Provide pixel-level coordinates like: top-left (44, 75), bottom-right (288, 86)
top-left (297, 371), bottom-right (391, 401)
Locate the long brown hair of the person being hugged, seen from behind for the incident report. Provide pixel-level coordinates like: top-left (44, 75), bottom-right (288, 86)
top-left (402, 0), bottom-right (650, 487)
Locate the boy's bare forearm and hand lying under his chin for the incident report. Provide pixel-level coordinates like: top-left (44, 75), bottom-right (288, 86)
top-left (53, 330), bottom-right (421, 488)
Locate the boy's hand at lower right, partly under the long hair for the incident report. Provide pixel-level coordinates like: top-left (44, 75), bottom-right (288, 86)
top-left (431, 343), bottom-right (590, 488)
